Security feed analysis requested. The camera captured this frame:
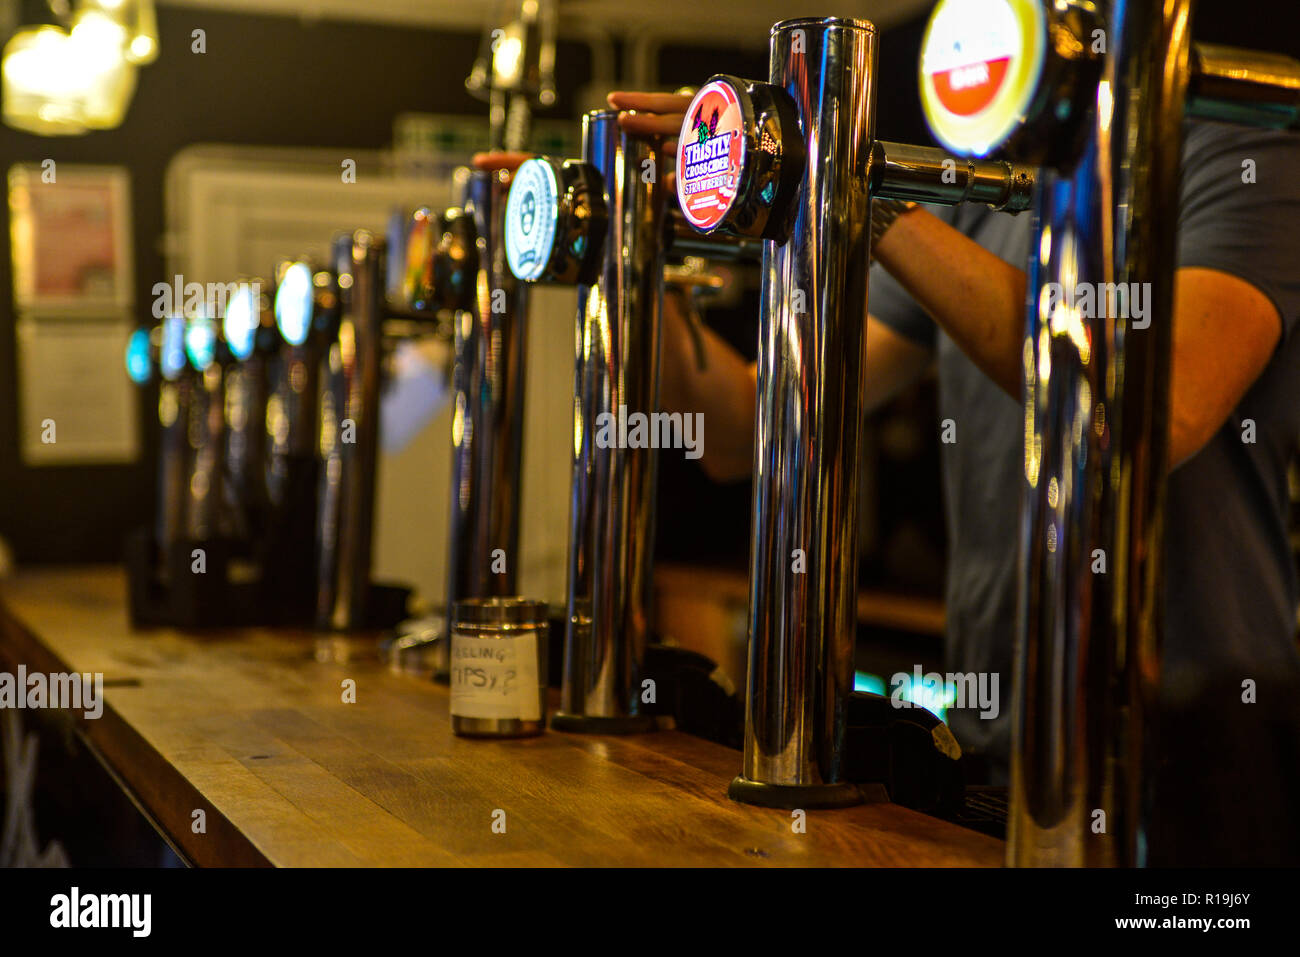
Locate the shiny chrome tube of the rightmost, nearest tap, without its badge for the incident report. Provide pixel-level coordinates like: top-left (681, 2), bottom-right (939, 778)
top-left (1008, 0), bottom-right (1188, 866)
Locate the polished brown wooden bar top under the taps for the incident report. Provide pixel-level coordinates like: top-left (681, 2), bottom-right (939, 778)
top-left (0, 568), bottom-right (1004, 867)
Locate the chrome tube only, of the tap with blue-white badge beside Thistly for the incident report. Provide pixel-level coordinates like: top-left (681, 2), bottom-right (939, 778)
top-left (553, 111), bottom-right (667, 732)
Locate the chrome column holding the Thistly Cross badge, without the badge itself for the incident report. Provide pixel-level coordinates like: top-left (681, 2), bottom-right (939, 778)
top-left (738, 20), bottom-right (876, 807)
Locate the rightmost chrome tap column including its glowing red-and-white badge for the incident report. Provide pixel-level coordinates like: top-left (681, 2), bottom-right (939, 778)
top-left (920, 0), bottom-right (1300, 866)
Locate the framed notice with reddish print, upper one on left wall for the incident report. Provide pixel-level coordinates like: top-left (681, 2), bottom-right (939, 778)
top-left (9, 160), bottom-right (134, 316)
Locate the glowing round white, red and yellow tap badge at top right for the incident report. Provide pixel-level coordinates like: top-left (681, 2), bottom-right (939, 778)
top-left (920, 0), bottom-right (1047, 156)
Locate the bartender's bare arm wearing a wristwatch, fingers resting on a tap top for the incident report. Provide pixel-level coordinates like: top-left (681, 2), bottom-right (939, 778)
top-left (610, 92), bottom-right (1282, 468)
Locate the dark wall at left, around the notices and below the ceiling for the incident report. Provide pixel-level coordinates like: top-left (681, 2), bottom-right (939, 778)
top-left (0, 7), bottom-right (590, 562)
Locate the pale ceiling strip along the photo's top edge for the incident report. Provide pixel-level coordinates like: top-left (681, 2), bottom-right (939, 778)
top-left (159, 0), bottom-right (933, 46)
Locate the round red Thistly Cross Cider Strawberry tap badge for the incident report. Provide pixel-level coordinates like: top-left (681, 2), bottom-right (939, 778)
top-left (677, 79), bottom-right (745, 233)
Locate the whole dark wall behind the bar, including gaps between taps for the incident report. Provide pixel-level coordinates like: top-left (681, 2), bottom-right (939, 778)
top-left (0, 0), bottom-right (1300, 562)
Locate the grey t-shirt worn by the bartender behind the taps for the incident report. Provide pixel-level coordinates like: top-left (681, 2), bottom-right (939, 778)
top-left (867, 124), bottom-right (1300, 783)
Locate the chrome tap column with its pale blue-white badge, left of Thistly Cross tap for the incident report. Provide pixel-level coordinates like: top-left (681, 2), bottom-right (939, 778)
top-left (507, 111), bottom-right (668, 733)
